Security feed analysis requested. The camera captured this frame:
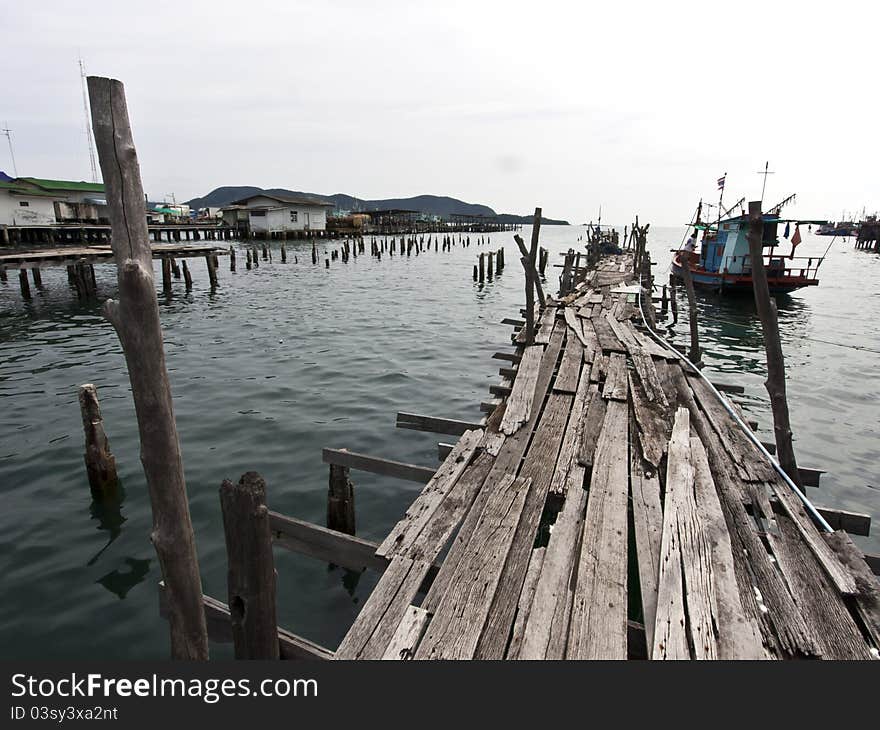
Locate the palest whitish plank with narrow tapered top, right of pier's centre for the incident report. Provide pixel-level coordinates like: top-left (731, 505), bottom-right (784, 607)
top-left (651, 409), bottom-right (701, 660)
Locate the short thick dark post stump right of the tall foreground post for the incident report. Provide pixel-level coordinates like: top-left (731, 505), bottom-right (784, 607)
top-left (220, 471), bottom-right (279, 659)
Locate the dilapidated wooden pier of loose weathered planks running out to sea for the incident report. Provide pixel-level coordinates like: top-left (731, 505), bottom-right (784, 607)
top-left (172, 249), bottom-right (880, 659)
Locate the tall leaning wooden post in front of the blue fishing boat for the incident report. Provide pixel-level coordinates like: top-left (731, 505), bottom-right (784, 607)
top-left (748, 200), bottom-right (802, 487)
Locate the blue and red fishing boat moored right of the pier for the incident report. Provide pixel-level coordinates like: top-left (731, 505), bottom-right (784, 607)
top-left (671, 195), bottom-right (827, 294)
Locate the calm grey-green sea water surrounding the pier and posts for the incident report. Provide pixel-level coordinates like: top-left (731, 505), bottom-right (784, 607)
top-left (0, 227), bottom-right (880, 659)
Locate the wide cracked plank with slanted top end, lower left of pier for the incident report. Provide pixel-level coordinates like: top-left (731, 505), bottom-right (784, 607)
top-left (416, 474), bottom-right (532, 659)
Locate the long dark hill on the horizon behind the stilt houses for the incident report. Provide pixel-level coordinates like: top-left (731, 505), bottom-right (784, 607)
top-left (187, 185), bottom-right (567, 225)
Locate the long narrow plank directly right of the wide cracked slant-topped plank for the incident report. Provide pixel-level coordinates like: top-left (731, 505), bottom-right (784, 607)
top-left (478, 393), bottom-right (574, 659)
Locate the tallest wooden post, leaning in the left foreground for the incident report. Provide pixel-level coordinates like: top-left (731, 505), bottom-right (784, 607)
top-left (88, 76), bottom-right (208, 659)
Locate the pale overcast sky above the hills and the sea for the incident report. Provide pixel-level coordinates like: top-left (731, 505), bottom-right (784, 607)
top-left (0, 0), bottom-right (880, 225)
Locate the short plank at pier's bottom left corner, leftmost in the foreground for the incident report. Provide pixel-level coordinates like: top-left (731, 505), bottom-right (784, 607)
top-left (336, 555), bottom-right (430, 659)
